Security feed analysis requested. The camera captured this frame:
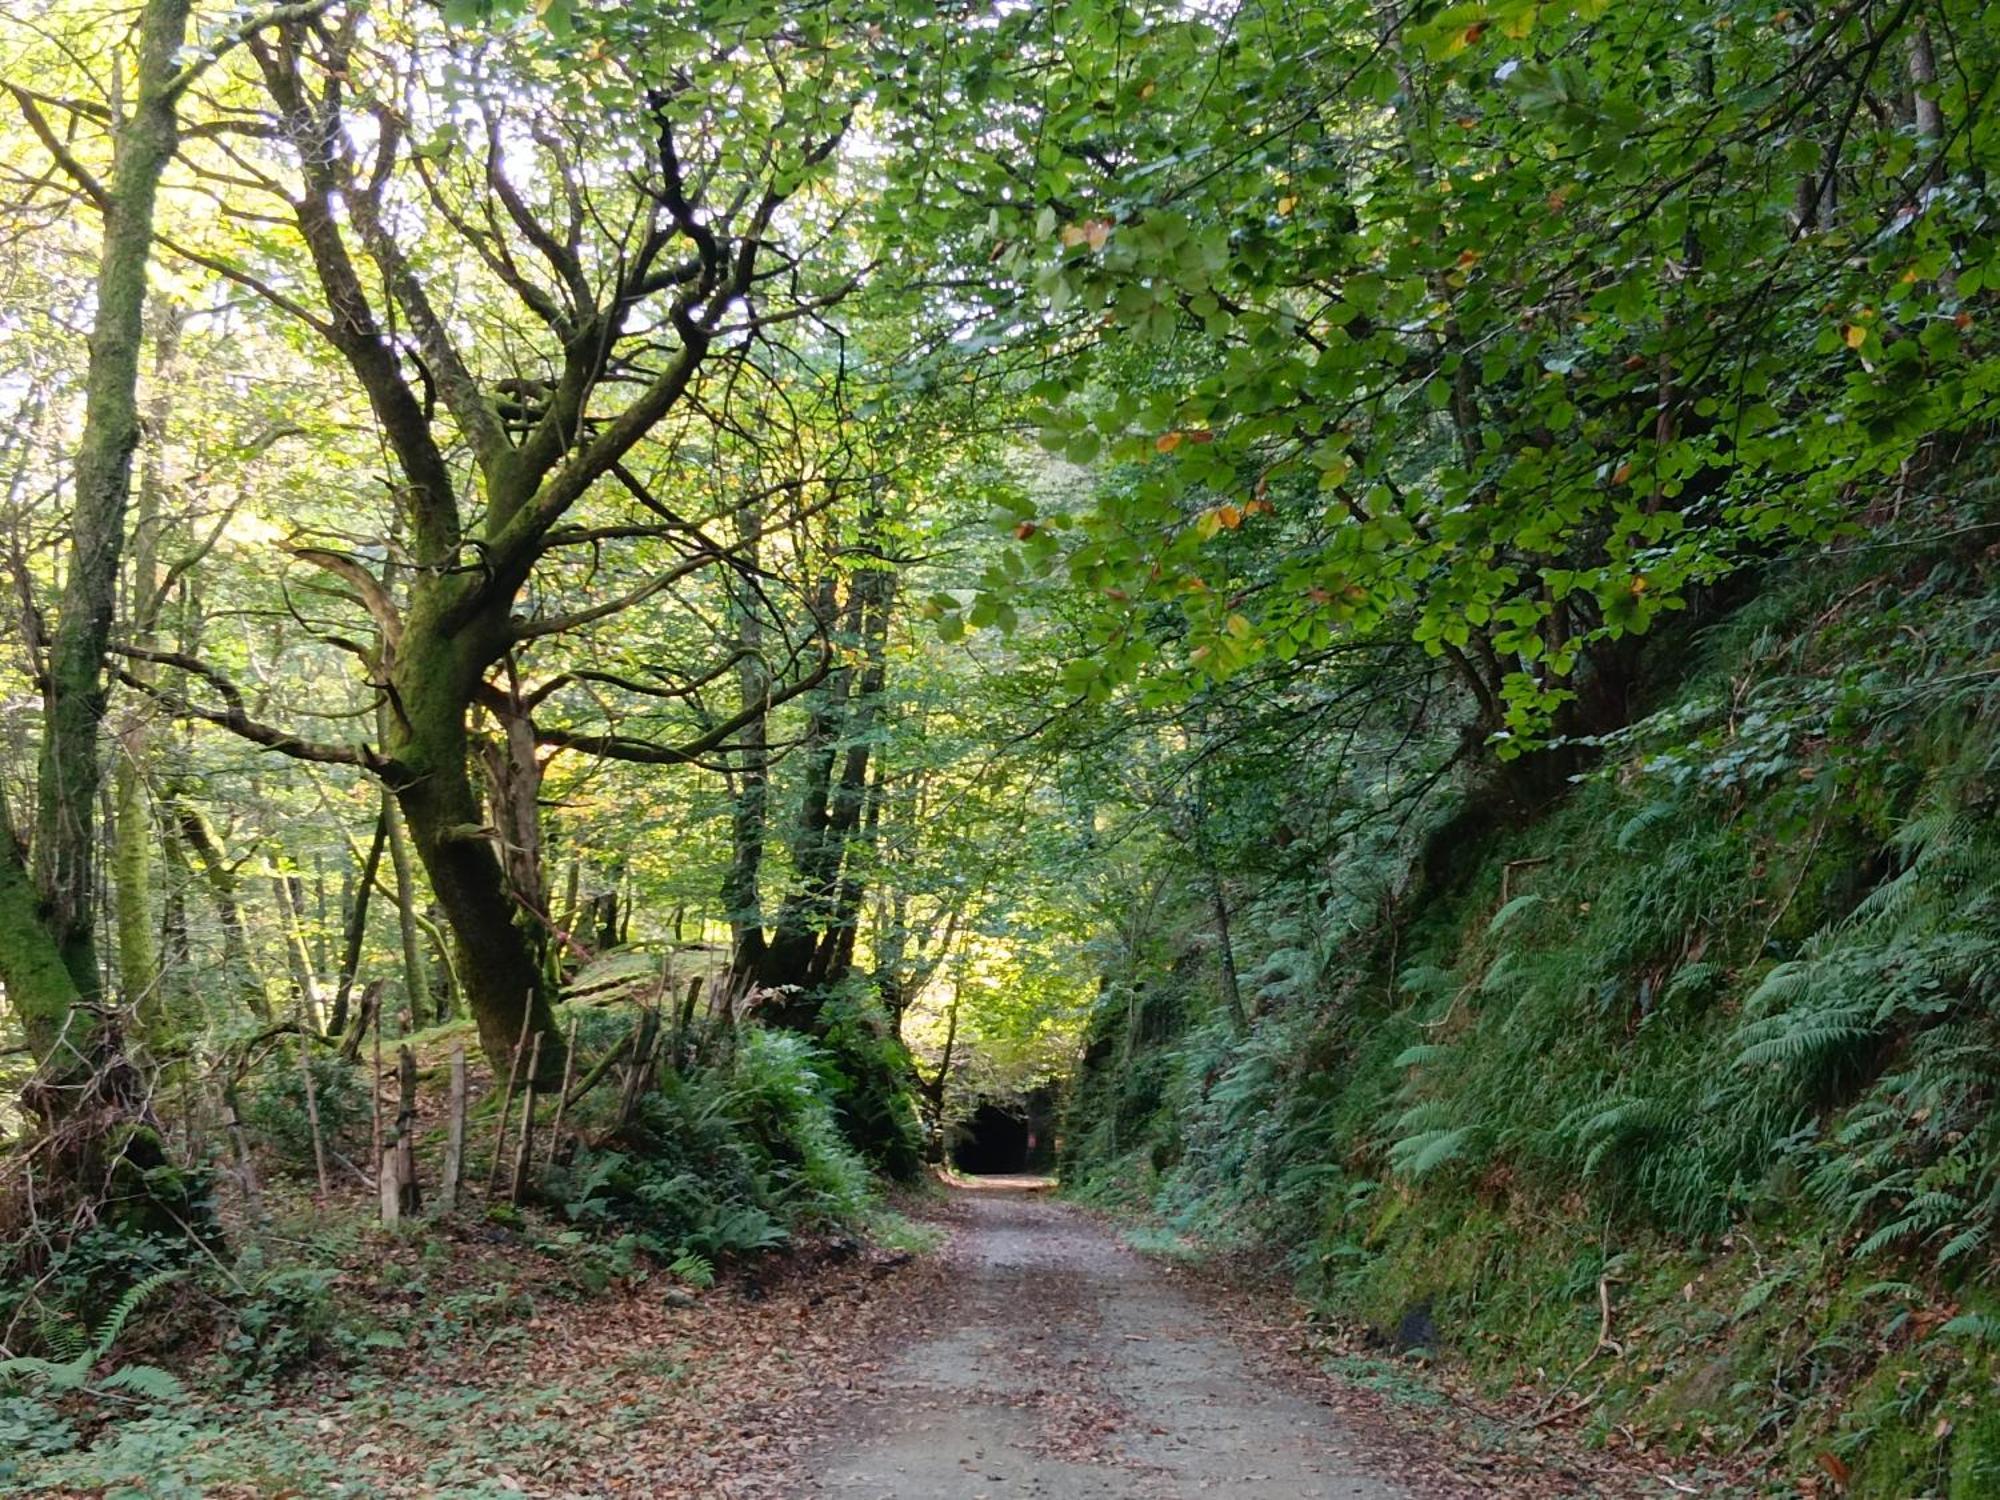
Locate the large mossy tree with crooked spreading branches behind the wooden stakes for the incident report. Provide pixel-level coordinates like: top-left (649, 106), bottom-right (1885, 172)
top-left (126, 6), bottom-right (900, 1076)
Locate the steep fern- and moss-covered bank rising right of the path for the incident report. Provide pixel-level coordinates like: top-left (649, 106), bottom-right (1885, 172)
top-left (1066, 514), bottom-right (2000, 1500)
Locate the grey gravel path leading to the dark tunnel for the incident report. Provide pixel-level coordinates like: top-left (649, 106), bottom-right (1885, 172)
top-left (806, 1178), bottom-right (1408, 1500)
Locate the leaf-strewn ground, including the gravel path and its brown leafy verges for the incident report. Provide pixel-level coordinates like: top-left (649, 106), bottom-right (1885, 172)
top-left (113, 1178), bottom-right (1742, 1500)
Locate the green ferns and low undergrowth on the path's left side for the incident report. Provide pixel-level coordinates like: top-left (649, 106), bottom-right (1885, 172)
top-left (0, 1010), bottom-right (896, 1496)
